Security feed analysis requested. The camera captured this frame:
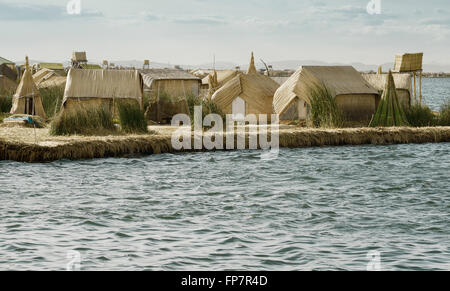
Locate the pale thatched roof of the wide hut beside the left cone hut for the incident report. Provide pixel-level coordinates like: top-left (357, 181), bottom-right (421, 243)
top-left (63, 69), bottom-right (142, 103)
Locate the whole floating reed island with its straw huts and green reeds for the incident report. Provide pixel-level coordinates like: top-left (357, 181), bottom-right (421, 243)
top-left (0, 52), bottom-right (450, 163)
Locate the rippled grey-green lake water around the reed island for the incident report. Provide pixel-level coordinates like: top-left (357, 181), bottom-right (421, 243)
top-left (0, 80), bottom-right (450, 270)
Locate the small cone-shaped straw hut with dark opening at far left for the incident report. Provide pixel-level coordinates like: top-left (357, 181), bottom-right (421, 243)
top-left (11, 57), bottom-right (46, 119)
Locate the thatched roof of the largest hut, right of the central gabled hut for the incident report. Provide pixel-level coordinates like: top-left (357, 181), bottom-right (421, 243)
top-left (273, 66), bottom-right (378, 114)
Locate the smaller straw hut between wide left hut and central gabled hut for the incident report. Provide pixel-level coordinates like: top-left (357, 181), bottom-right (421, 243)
top-left (140, 69), bottom-right (201, 123)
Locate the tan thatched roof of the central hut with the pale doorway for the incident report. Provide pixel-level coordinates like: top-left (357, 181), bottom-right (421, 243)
top-left (212, 74), bottom-right (279, 114)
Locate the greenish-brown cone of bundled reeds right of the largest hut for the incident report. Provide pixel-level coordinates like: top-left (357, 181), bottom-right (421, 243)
top-left (370, 71), bottom-right (408, 127)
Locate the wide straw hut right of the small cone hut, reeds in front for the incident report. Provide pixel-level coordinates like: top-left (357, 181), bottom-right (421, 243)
top-left (63, 69), bottom-right (143, 112)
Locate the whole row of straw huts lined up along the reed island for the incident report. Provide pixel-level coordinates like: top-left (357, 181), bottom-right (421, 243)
top-left (0, 53), bottom-right (422, 123)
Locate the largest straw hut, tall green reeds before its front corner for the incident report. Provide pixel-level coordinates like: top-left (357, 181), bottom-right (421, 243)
top-left (273, 66), bottom-right (380, 121)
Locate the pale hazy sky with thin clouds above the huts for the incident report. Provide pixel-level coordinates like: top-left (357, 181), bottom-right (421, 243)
top-left (0, 0), bottom-right (450, 65)
